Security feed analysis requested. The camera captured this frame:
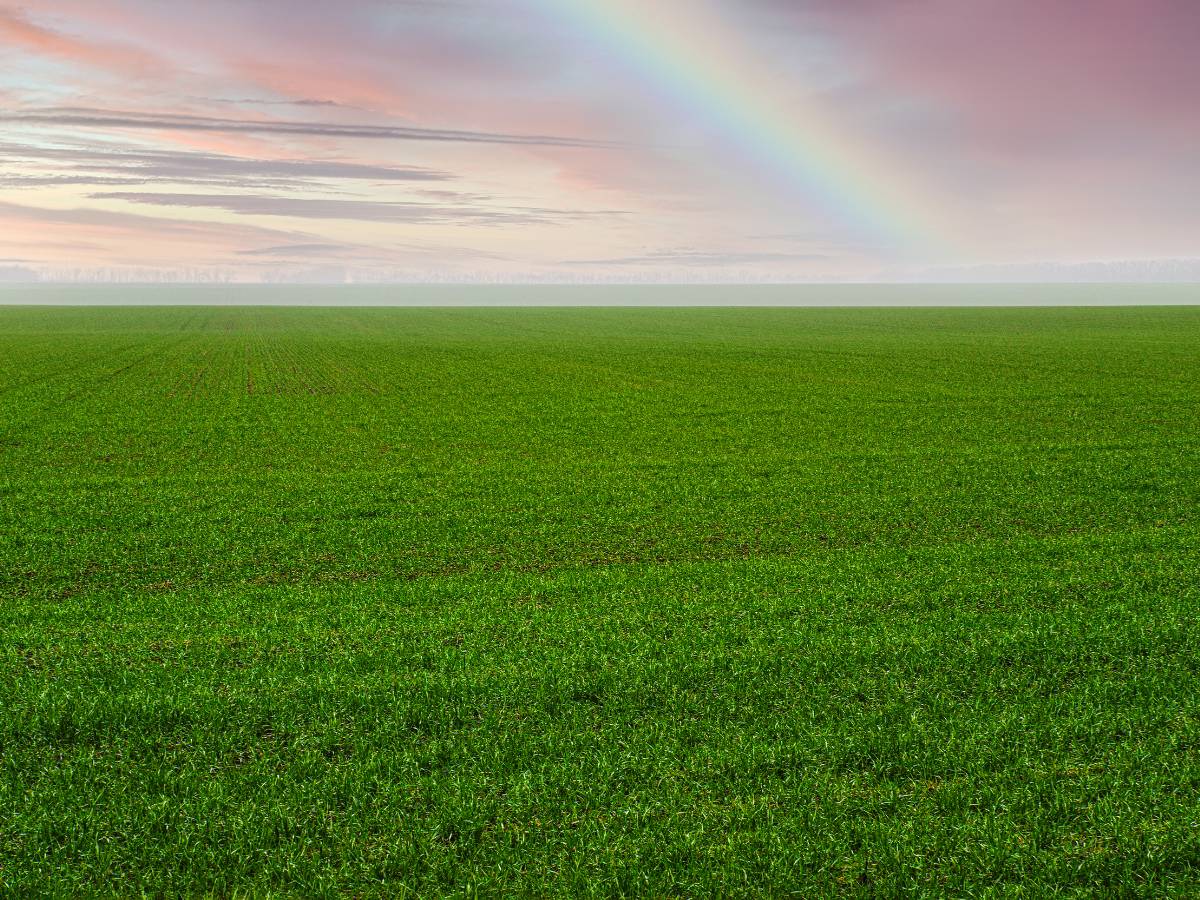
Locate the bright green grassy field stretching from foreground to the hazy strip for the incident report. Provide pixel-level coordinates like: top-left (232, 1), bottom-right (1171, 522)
top-left (0, 308), bottom-right (1200, 896)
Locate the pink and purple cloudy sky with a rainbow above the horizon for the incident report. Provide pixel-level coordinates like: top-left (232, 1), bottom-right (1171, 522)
top-left (0, 0), bottom-right (1200, 282)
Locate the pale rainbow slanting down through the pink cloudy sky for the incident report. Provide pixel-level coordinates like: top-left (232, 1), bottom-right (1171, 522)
top-left (541, 0), bottom-right (954, 251)
